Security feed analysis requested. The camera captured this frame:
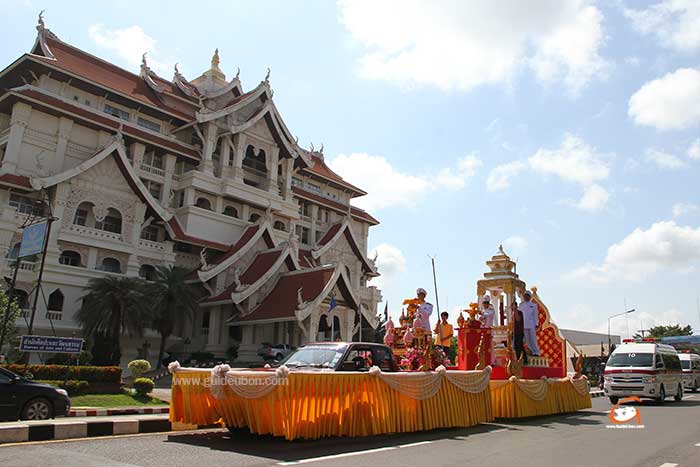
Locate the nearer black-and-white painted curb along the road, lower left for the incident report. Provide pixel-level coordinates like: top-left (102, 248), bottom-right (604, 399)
top-left (0, 416), bottom-right (220, 445)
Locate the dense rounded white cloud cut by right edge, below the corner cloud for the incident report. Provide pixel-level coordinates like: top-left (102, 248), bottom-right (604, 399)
top-left (627, 68), bottom-right (700, 130)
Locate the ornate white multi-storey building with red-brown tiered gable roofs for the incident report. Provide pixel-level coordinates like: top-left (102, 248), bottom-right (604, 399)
top-left (0, 17), bottom-right (381, 362)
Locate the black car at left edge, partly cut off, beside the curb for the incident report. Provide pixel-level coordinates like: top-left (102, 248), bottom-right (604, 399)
top-left (0, 368), bottom-right (70, 420)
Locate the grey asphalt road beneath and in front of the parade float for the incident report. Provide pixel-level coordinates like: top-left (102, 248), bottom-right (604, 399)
top-left (0, 393), bottom-right (700, 467)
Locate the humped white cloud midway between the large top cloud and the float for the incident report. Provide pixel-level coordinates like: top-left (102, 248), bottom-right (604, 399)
top-left (528, 133), bottom-right (610, 186)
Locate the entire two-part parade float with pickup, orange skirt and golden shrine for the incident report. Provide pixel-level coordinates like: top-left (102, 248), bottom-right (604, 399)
top-left (170, 248), bottom-right (591, 440)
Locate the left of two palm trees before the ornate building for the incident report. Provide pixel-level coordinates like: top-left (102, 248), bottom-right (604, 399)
top-left (76, 276), bottom-right (149, 365)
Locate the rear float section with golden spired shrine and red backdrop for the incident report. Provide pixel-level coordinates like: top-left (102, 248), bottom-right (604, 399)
top-left (456, 247), bottom-right (591, 418)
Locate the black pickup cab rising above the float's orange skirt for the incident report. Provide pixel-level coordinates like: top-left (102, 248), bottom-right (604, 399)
top-left (281, 342), bottom-right (398, 371)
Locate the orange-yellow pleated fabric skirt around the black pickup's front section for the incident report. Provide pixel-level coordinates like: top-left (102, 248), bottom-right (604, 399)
top-left (170, 368), bottom-right (493, 440)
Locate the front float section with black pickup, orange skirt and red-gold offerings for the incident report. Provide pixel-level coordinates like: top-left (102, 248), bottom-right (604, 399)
top-left (169, 288), bottom-right (494, 440)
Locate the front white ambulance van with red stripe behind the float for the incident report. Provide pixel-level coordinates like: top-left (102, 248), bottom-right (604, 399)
top-left (603, 339), bottom-right (683, 404)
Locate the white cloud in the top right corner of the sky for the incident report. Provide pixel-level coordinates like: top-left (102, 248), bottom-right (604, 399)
top-left (625, 0), bottom-right (700, 52)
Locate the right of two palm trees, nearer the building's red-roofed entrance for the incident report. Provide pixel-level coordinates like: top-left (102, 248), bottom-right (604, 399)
top-left (148, 266), bottom-right (199, 368)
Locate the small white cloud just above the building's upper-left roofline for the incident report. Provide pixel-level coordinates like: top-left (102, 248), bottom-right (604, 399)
top-left (88, 24), bottom-right (173, 76)
